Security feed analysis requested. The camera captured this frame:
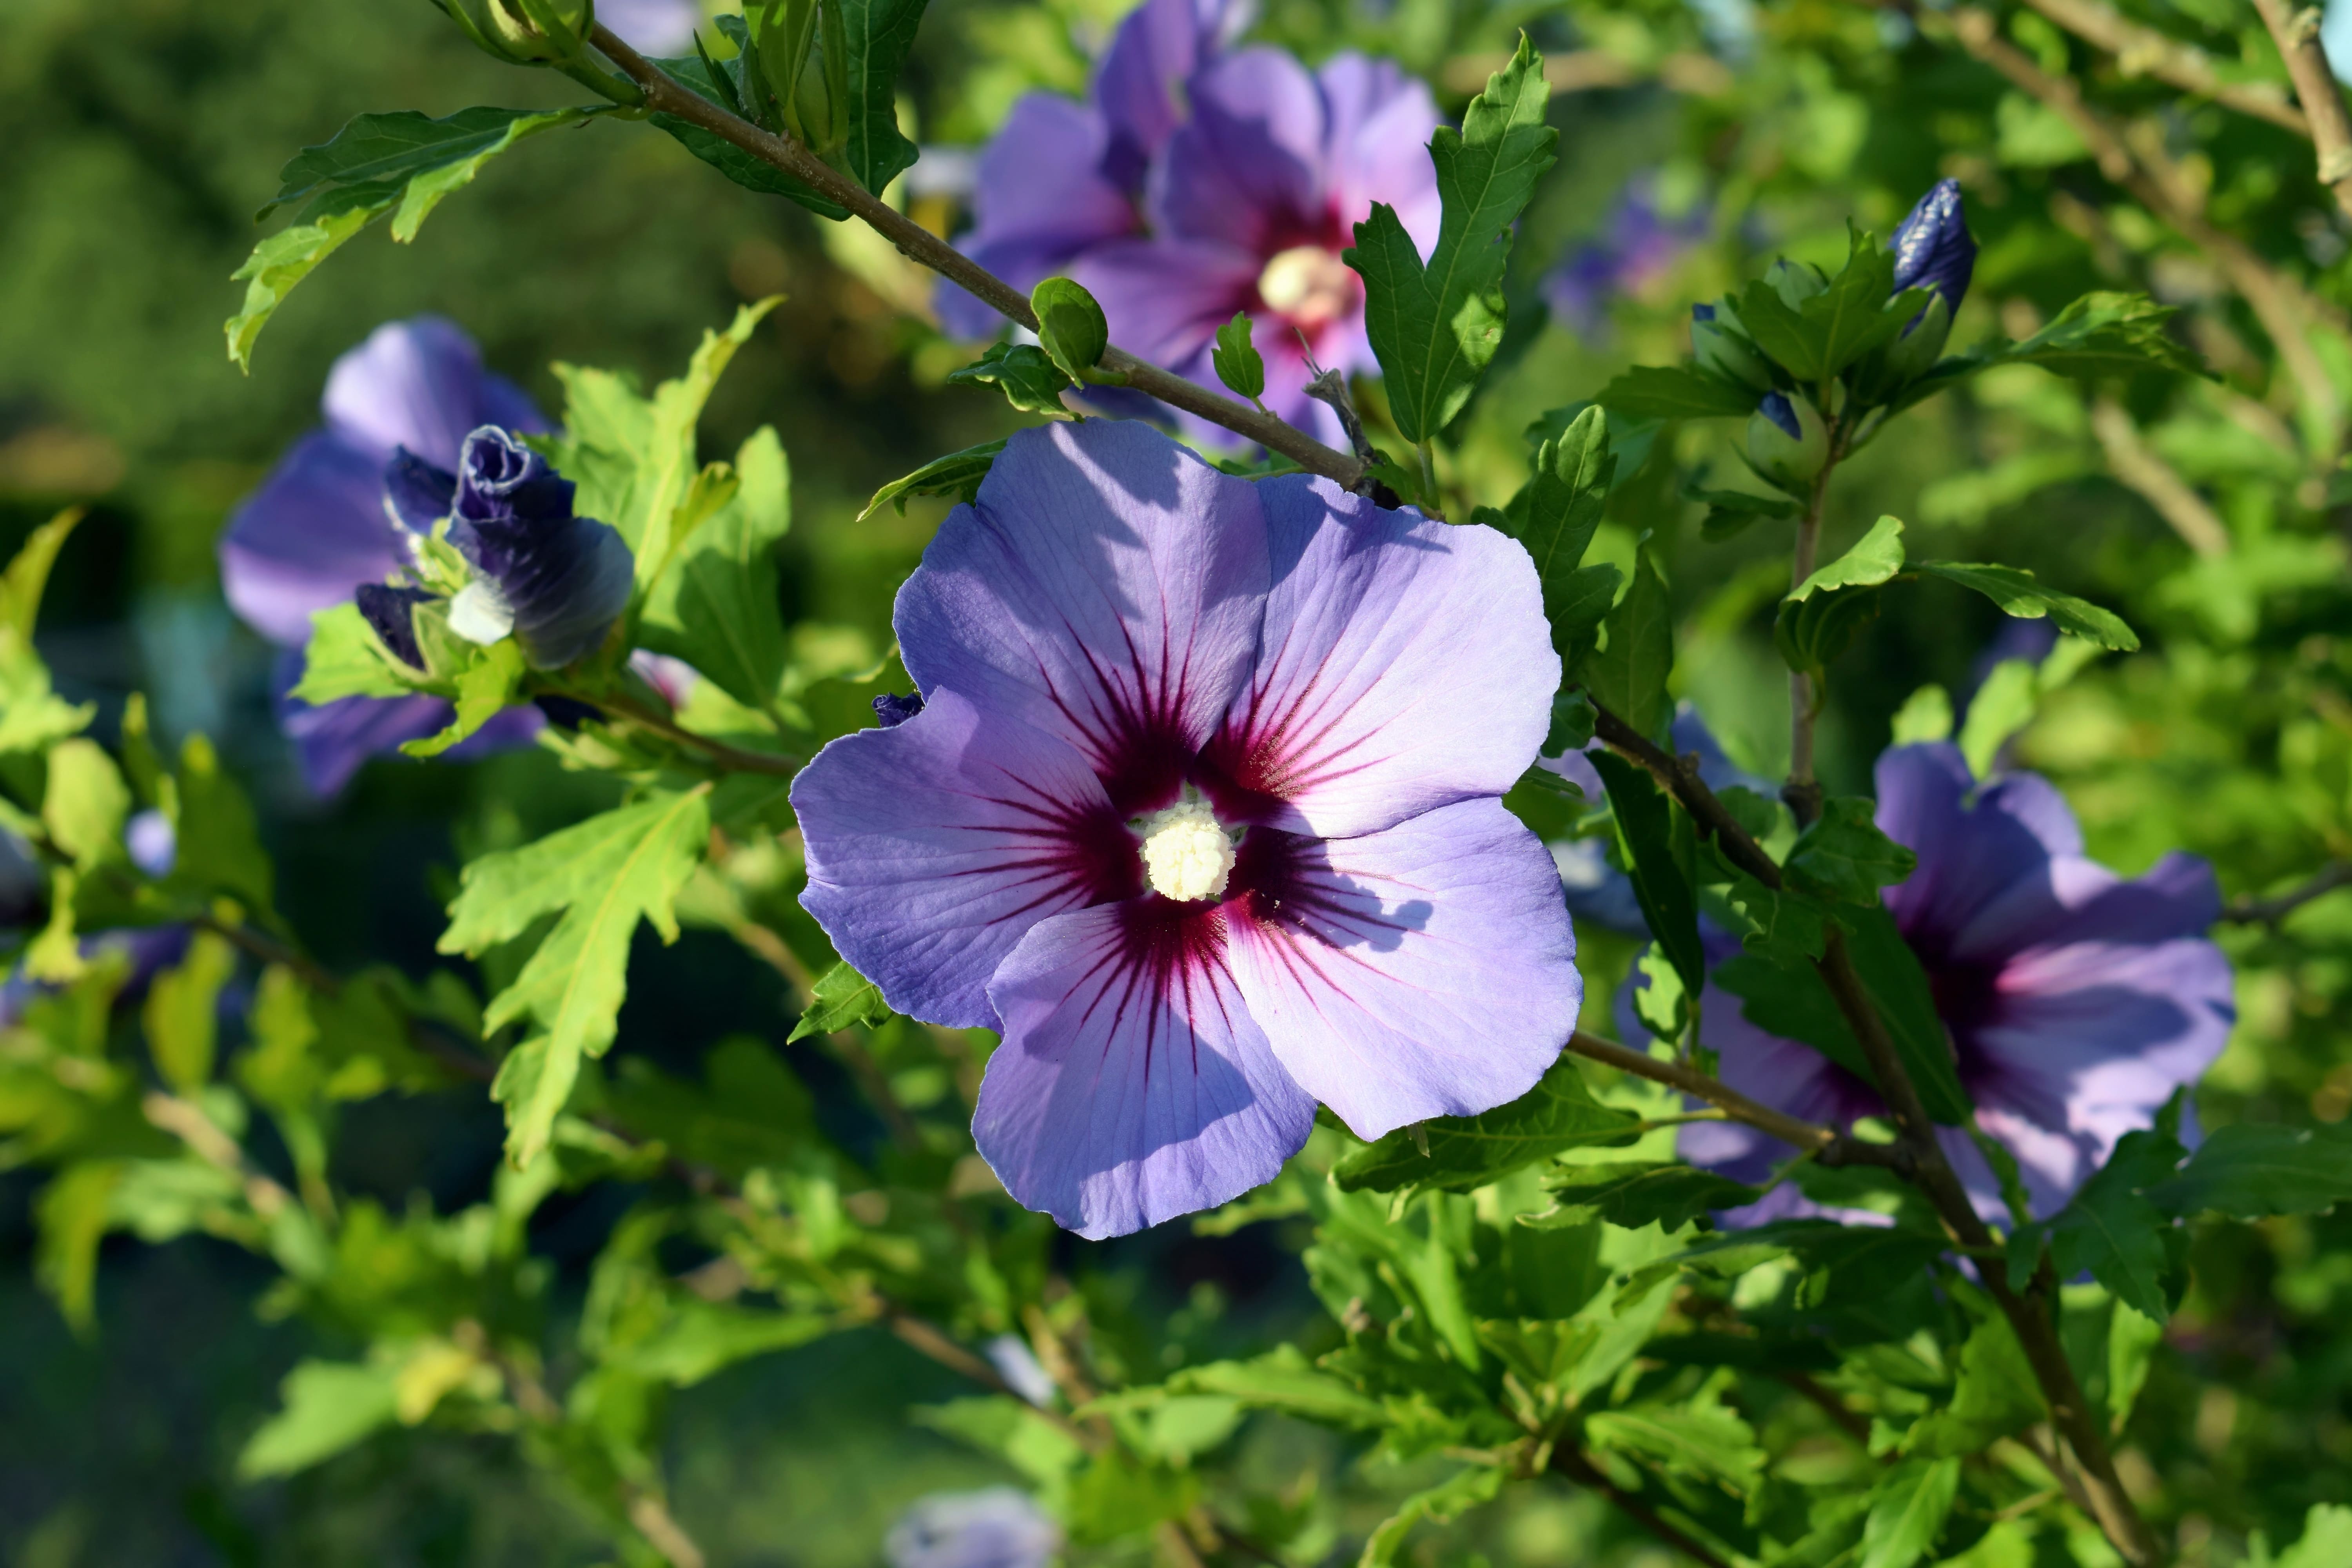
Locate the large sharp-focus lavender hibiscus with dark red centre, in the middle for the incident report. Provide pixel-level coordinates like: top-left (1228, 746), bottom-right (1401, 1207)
top-left (793, 421), bottom-right (1583, 1236)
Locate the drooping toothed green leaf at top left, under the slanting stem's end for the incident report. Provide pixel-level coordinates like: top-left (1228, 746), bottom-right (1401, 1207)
top-left (226, 103), bottom-right (612, 369)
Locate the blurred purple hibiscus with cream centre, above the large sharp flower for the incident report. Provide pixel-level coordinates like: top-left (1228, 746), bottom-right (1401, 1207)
top-left (943, 0), bottom-right (1439, 442)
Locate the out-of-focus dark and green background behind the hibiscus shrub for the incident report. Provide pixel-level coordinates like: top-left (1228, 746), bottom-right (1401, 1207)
top-left (0, 0), bottom-right (2352, 1568)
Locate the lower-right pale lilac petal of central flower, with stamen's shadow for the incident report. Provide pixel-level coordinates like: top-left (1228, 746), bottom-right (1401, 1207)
top-left (1225, 799), bottom-right (1583, 1138)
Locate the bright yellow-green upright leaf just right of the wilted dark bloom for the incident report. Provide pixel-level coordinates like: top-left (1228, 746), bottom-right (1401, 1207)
top-left (532, 296), bottom-right (783, 583)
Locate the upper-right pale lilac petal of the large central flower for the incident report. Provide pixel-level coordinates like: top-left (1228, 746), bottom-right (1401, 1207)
top-left (1202, 475), bottom-right (1559, 839)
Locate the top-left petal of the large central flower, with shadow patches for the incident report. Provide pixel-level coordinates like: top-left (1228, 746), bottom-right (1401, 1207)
top-left (896, 418), bottom-right (1268, 816)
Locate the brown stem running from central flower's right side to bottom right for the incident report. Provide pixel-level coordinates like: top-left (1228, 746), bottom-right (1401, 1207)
top-left (1588, 693), bottom-right (2157, 1568)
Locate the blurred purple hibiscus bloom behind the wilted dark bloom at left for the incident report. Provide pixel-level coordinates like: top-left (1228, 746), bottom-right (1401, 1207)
top-left (221, 315), bottom-right (550, 795)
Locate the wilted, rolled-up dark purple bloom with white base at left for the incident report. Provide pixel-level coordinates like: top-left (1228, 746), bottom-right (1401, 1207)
top-left (390, 425), bottom-right (637, 670)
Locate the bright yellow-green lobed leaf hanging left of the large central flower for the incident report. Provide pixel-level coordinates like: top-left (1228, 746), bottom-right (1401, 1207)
top-left (440, 785), bottom-right (710, 1166)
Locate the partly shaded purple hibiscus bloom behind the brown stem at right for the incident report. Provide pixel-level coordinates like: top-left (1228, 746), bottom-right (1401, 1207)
top-left (1682, 743), bottom-right (2234, 1222)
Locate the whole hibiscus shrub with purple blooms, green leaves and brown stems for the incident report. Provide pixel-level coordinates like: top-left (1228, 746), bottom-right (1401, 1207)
top-left (0, 0), bottom-right (2352, 1568)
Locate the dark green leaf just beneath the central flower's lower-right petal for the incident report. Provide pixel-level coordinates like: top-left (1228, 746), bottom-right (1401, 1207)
top-left (1331, 1056), bottom-right (1642, 1192)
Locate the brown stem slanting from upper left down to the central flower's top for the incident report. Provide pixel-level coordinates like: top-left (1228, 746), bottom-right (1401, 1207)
top-left (590, 26), bottom-right (1364, 489)
